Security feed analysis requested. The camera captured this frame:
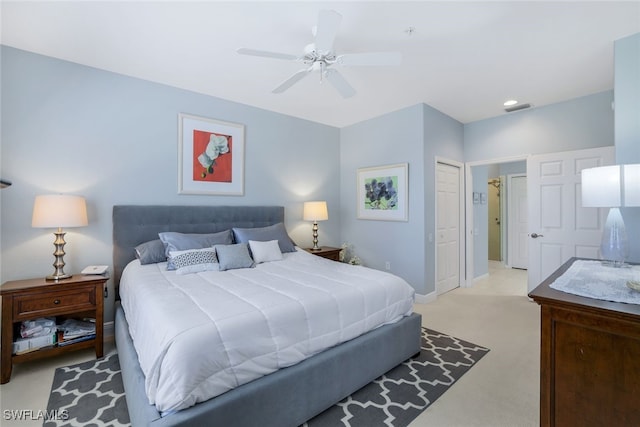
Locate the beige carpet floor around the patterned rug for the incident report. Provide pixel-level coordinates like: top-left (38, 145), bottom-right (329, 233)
top-left (0, 263), bottom-right (540, 427)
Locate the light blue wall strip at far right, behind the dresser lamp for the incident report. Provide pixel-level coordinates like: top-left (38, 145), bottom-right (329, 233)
top-left (614, 33), bottom-right (640, 262)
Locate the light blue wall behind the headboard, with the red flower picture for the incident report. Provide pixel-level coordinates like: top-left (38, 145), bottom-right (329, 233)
top-left (0, 46), bottom-right (341, 320)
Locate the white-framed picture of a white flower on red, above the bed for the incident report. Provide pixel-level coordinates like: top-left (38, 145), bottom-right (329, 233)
top-left (178, 113), bottom-right (244, 196)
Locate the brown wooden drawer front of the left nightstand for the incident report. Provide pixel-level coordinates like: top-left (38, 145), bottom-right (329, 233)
top-left (13, 286), bottom-right (96, 319)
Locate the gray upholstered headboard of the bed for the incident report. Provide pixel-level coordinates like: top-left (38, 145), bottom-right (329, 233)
top-left (113, 205), bottom-right (284, 295)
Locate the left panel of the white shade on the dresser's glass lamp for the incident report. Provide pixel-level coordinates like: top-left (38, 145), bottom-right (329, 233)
top-left (582, 165), bottom-right (621, 208)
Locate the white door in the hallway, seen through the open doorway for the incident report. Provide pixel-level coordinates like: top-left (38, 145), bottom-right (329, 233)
top-left (507, 175), bottom-right (529, 269)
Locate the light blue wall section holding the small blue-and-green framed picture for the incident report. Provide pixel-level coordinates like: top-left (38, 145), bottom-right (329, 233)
top-left (340, 105), bottom-right (425, 293)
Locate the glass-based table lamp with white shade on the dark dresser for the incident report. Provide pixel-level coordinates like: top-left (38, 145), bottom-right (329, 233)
top-left (582, 164), bottom-right (640, 267)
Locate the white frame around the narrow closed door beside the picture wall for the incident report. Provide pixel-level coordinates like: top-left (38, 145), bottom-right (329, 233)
top-left (436, 156), bottom-right (467, 297)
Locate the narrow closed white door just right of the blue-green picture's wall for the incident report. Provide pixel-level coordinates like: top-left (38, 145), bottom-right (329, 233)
top-left (436, 163), bottom-right (463, 295)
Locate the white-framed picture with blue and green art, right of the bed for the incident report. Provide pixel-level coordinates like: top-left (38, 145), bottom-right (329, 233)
top-left (356, 163), bottom-right (409, 221)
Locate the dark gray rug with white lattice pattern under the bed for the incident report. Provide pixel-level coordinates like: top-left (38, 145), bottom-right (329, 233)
top-left (43, 328), bottom-right (489, 427)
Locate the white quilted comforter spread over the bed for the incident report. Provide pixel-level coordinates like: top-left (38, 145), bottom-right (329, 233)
top-left (120, 250), bottom-right (414, 413)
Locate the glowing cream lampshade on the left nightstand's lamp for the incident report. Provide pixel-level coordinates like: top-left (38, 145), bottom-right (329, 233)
top-left (31, 194), bottom-right (89, 228)
